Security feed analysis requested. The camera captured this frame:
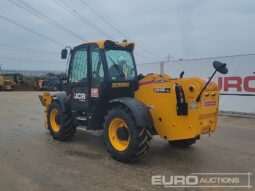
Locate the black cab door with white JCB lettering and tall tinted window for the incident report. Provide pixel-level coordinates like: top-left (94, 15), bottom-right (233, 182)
top-left (68, 45), bottom-right (90, 112)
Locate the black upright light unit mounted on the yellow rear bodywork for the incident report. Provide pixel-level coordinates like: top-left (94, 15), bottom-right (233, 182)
top-left (175, 84), bottom-right (188, 115)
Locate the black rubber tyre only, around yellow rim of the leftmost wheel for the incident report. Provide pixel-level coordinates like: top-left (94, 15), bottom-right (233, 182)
top-left (47, 101), bottom-right (75, 141)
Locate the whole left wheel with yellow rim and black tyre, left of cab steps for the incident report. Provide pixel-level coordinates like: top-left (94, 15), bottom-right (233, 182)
top-left (47, 102), bottom-right (75, 141)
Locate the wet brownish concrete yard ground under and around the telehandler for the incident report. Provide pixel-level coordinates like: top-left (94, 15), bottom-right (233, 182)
top-left (0, 92), bottom-right (255, 191)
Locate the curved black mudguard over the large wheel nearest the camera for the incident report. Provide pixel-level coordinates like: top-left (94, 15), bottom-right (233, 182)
top-left (109, 97), bottom-right (153, 128)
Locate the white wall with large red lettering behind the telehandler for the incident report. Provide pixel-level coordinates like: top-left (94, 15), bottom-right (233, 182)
top-left (138, 54), bottom-right (255, 113)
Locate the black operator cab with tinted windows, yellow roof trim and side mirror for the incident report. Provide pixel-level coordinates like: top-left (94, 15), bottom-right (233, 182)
top-left (61, 40), bottom-right (138, 129)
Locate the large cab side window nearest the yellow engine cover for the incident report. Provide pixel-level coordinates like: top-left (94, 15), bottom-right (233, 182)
top-left (106, 50), bottom-right (136, 81)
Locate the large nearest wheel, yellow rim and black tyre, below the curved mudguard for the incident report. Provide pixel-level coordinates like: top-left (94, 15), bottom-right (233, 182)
top-left (104, 107), bottom-right (151, 163)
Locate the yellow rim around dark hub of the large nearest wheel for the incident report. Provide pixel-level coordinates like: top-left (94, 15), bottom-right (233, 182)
top-left (108, 118), bottom-right (130, 151)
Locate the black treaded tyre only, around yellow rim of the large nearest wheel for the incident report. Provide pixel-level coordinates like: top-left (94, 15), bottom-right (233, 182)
top-left (104, 106), bottom-right (151, 163)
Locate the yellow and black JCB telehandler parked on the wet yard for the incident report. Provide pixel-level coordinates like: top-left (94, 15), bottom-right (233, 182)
top-left (39, 40), bottom-right (228, 162)
